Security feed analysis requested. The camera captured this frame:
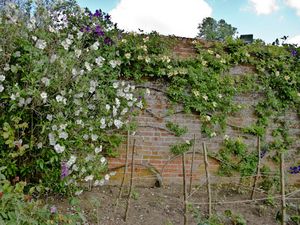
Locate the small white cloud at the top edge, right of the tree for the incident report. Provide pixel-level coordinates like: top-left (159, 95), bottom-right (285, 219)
top-left (250, 0), bottom-right (278, 15)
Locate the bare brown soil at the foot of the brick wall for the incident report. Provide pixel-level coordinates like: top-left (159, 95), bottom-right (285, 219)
top-left (52, 186), bottom-right (300, 225)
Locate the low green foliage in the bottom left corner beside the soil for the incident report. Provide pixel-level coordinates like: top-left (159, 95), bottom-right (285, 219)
top-left (0, 168), bottom-right (84, 225)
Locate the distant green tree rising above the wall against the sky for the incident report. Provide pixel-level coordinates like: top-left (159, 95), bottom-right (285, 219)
top-left (198, 17), bottom-right (237, 41)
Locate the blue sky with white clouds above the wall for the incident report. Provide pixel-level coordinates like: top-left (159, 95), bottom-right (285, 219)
top-left (77, 0), bottom-right (300, 46)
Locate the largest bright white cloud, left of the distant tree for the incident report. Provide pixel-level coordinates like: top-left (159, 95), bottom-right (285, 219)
top-left (110, 0), bottom-right (212, 37)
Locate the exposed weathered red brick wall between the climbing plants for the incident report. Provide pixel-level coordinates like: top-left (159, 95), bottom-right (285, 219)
top-left (109, 38), bottom-right (300, 186)
